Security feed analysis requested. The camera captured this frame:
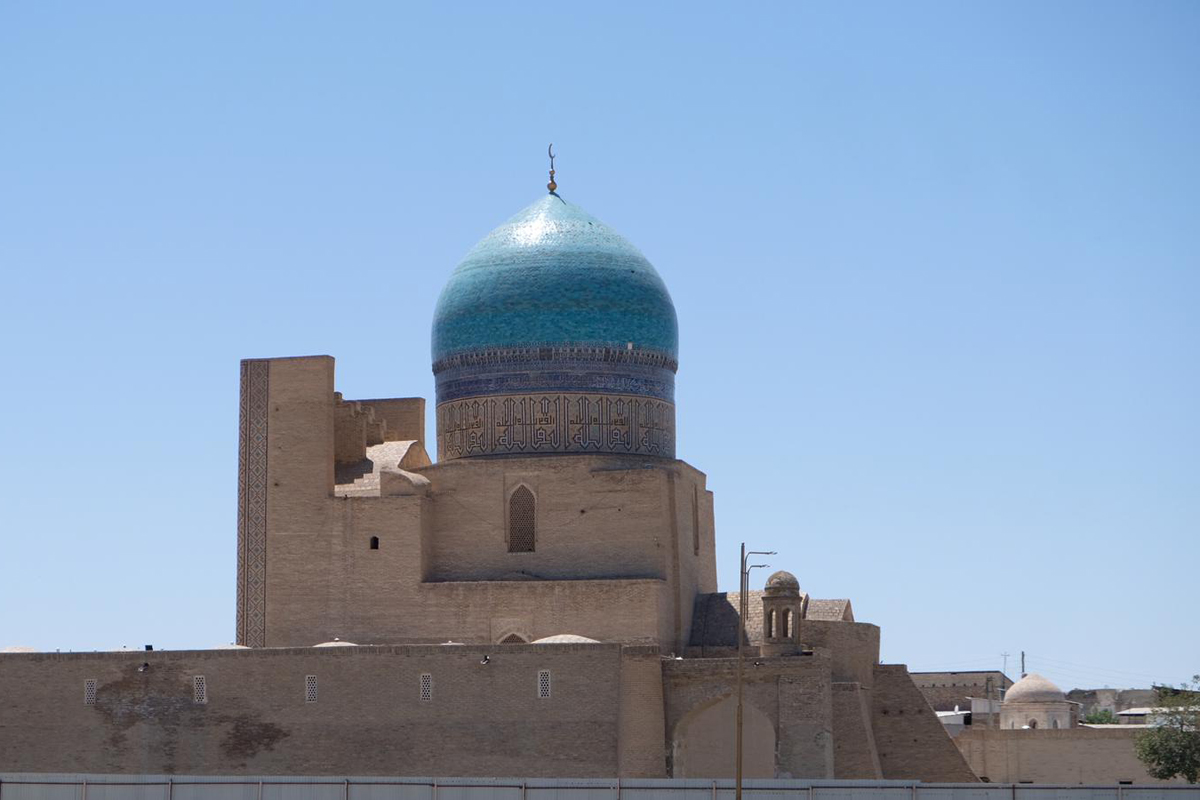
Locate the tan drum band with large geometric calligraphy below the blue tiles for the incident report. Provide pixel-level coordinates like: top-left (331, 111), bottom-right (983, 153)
top-left (438, 392), bottom-right (674, 461)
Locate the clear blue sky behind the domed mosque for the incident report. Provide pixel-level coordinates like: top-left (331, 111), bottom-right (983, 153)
top-left (0, 1), bottom-right (1200, 688)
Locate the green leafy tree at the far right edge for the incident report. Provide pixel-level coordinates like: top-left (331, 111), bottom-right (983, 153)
top-left (1134, 675), bottom-right (1200, 783)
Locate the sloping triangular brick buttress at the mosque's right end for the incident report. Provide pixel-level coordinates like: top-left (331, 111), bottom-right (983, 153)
top-left (871, 664), bottom-right (978, 782)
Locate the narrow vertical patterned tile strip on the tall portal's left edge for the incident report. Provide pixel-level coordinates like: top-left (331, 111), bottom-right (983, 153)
top-left (238, 361), bottom-right (271, 648)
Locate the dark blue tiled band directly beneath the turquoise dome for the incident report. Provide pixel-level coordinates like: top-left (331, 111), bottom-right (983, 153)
top-left (433, 345), bottom-right (676, 403)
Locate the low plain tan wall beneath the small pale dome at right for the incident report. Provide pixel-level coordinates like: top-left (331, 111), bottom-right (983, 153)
top-left (954, 726), bottom-right (1182, 784)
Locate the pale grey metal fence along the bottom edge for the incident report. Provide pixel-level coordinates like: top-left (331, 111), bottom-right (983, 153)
top-left (0, 774), bottom-right (1200, 800)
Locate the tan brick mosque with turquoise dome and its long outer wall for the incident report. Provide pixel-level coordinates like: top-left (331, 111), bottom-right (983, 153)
top-left (0, 185), bottom-right (976, 781)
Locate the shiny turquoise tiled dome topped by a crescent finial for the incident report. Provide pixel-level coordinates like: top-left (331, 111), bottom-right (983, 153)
top-left (432, 194), bottom-right (679, 365)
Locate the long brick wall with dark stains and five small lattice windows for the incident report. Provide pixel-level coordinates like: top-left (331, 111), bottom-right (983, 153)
top-left (0, 644), bottom-right (662, 777)
